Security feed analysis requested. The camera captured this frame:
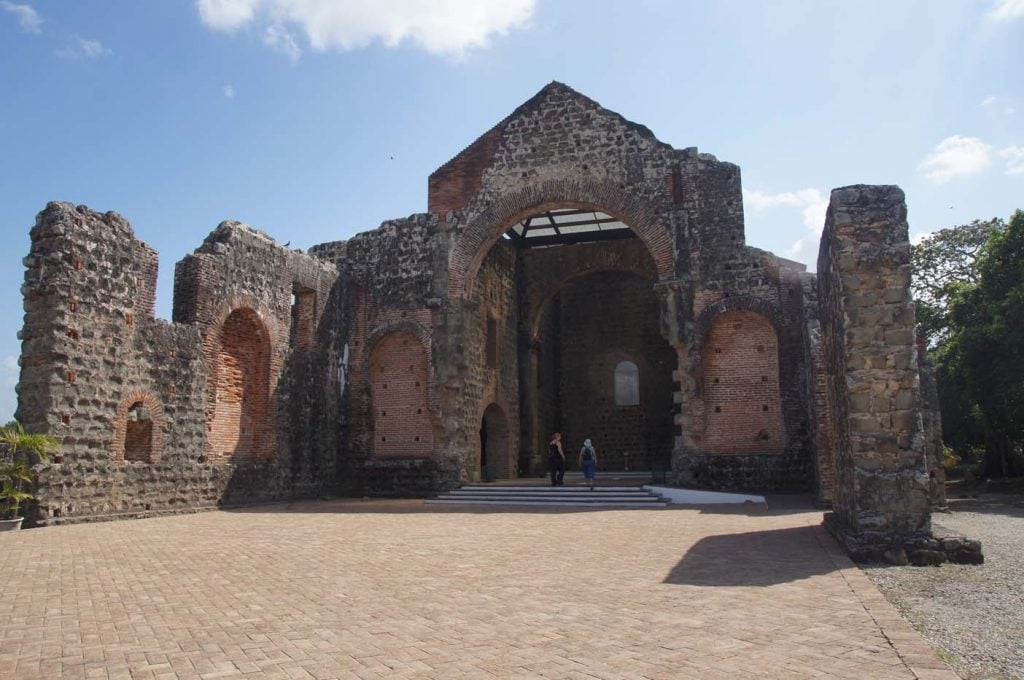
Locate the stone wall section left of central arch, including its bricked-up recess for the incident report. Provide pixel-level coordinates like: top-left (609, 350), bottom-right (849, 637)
top-left (309, 214), bottom-right (460, 496)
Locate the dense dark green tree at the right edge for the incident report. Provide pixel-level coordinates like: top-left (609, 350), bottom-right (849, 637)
top-left (941, 210), bottom-right (1024, 476)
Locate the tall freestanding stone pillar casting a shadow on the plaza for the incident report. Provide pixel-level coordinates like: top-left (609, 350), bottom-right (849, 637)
top-left (818, 185), bottom-right (981, 564)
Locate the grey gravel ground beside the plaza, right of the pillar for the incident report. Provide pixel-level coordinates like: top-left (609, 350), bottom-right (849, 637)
top-left (864, 494), bottom-right (1024, 680)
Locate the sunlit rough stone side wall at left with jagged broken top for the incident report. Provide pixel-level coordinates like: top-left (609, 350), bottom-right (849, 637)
top-left (16, 203), bottom-right (334, 523)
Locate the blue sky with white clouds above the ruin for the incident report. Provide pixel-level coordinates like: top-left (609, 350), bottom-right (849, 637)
top-left (0, 0), bottom-right (1024, 422)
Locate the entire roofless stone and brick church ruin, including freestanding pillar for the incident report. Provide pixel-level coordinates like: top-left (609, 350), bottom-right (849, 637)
top-left (16, 83), bottom-right (963, 559)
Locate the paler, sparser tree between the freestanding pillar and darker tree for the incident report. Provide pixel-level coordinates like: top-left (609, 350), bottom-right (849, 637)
top-left (910, 217), bottom-right (1006, 348)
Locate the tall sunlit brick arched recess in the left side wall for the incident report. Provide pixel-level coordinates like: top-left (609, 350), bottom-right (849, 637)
top-left (208, 307), bottom-right (272, 463)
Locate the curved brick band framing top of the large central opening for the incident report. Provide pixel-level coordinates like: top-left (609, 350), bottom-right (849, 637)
top-left (449, 179), bottom-right (674, 298)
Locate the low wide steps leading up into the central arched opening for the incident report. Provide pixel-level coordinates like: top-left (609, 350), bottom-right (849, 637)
top-left (426, 484), bottom-right (669, 509)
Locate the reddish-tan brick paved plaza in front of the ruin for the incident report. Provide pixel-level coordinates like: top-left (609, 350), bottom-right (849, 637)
top-left (0, 501), bottom-right (956, 680)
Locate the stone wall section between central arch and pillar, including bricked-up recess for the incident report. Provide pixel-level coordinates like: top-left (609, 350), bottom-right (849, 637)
top-left (672, 247), bottom-right (816, 493)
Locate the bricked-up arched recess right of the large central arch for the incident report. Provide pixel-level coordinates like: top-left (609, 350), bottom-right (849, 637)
top-left (699, 309), bottom-right (784, 454)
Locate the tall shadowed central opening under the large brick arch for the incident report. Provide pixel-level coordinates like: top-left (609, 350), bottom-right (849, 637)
top-left (466, 202), bottom-right (679, 474)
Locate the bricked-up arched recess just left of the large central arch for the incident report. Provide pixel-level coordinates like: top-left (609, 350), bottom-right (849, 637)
top-left (370, 330), bottom-right (434, 458)
